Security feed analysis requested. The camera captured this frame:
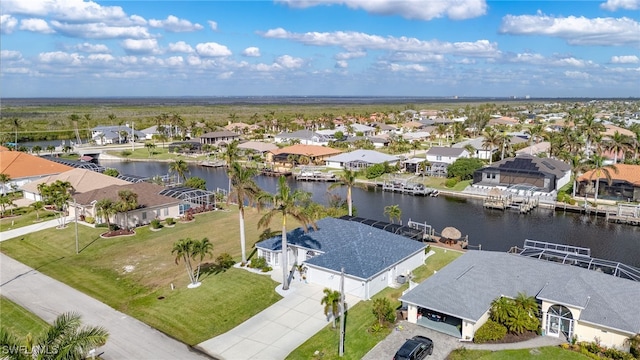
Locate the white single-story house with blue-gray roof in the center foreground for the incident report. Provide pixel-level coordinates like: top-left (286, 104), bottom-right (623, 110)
top-left (256, 218), bottom-right (425, 300)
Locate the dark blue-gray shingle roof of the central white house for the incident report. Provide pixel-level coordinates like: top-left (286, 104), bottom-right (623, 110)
top-left (256, 218), bottom-right (425, 279)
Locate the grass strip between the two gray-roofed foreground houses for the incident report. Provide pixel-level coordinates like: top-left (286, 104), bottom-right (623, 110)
top-left (287, 248), bottom-right (462, 360)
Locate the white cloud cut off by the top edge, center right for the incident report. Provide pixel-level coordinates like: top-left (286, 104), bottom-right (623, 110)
top-left (278, 0), bottom-right (487, 20)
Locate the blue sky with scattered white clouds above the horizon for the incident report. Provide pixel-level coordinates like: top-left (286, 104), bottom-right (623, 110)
top-left (0, 0), bottom-right (640, 97)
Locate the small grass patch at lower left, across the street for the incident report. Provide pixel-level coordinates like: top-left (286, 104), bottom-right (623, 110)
top-left (0, 296), bottom-right (49, 339)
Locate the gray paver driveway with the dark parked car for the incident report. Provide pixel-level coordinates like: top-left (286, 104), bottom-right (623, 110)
top-left (362, 321), bottom-right (562, 360)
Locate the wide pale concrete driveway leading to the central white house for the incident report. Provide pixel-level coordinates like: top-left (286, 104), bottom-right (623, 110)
top-left (196, 271), bottom-right (358, 360)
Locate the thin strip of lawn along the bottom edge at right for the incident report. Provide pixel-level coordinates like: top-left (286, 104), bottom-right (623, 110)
top-left (447, 346), bottom-right (589, 360)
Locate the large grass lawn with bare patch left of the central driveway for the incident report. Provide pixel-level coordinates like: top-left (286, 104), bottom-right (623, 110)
top-left (0, 208), bottom-right (290, 344)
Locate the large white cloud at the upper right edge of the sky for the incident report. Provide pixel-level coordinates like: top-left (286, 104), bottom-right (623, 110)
top-left (500, 13), bottom-right (640, 47)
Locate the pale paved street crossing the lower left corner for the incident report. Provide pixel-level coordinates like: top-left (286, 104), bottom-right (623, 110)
top-left (0, 254), bottom-right (207, 360)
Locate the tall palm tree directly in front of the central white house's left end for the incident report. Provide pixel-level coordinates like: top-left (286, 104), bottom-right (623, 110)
top-left (258, 176), bottom-right (316, 290)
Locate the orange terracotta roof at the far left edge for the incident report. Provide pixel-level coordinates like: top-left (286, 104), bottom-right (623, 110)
top-left (0, 151), bottom-right (72, 180)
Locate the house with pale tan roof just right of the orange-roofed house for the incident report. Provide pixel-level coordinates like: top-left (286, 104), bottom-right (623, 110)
top-left (20, 168), bottom-right (130, 201)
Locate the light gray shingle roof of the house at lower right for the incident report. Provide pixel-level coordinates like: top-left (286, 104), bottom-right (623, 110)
top-left (401, 251), bottom-right (640, 334)
